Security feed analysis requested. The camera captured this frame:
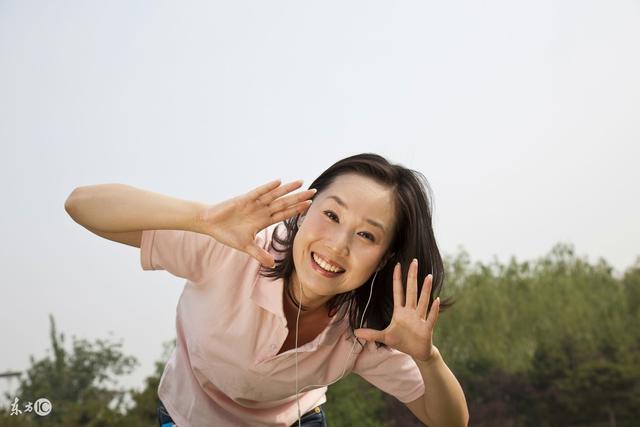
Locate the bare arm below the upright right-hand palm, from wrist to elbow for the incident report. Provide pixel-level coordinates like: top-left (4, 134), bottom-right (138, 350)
top-left (406, 348), bottom-right (469, 427)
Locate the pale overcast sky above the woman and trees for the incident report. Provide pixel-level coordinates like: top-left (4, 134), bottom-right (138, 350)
top-left (0, 0), bottom-right (640, 405)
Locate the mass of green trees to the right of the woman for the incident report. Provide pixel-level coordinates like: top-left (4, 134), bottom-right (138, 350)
top-left (434, 244), bottom-right (640, 427)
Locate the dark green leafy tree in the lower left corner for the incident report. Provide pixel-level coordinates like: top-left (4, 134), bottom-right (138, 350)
top-left (0, 315), bottom-right (138, 427)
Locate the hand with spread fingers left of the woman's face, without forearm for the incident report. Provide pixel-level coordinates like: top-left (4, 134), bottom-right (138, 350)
top-left (198, 179), bottom-right (316, 267)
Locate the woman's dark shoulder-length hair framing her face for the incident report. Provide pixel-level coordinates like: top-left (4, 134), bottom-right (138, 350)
top-left (260, 153), bottom-right (454, 348)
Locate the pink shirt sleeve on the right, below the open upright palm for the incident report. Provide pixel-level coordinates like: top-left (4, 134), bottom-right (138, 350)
top-left (353, 342), bottom-right (424, 403)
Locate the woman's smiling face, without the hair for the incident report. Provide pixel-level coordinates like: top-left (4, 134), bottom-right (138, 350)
top-left (292, 174), bottom-right (395, 305)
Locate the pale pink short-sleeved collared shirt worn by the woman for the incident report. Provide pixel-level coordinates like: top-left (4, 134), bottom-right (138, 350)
top-left (140, 224), bottom-right (424, 427)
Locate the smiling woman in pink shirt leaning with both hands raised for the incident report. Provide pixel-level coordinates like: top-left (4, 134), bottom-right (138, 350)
top-left (65, 154), bottom-right (468, 427)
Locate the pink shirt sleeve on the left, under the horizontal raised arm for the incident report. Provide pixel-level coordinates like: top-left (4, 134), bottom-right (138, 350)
top-left (140, 230), bottom-right (225, 282)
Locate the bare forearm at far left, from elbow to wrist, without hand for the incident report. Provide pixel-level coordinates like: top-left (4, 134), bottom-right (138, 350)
top-left (64, 184), bottom-right (207, 233)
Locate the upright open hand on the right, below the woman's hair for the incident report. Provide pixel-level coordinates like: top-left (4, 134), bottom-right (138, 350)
top-left (355, 259), bottom-right (440, 361)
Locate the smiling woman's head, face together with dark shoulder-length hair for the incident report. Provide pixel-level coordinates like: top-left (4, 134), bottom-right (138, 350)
top-left (263, 153), bottom-right (453, 347)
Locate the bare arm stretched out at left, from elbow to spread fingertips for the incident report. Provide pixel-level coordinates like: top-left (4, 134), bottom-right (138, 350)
top-left (64, 179), bottom-right (316, 267)
